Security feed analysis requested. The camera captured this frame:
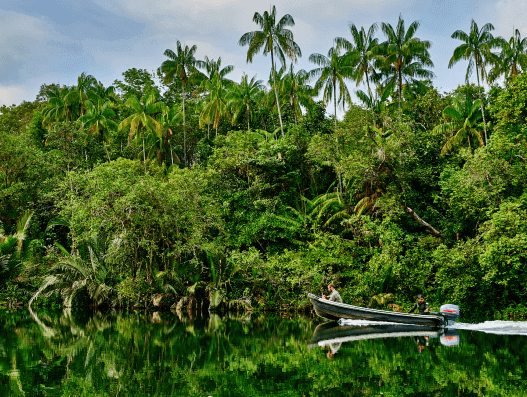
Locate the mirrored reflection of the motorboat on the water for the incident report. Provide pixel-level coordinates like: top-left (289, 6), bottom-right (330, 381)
top-left (307, 322), bottom-right (459, 349)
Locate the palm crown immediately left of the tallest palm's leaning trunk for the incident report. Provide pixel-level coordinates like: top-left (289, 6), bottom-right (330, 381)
top-left (226, 74), bottom-right (265, 131)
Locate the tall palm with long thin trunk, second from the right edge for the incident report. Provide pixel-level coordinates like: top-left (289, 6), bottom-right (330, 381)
top-left (448, 19), bottom-right (498, 144)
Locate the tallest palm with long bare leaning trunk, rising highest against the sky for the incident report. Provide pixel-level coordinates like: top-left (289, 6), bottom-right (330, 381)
top-left (238, 6), bottom-right (302, 136)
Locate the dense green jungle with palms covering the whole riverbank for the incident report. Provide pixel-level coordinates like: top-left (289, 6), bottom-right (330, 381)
top-left (0, 7), bottom-right (527, 319)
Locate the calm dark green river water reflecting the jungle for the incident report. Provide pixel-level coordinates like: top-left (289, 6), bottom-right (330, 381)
top-left (0, 311), bottom-right (527, 397)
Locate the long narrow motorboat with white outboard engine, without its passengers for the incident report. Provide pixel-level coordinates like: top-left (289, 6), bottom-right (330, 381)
top-left (308, 294), bottom-right (459, 327)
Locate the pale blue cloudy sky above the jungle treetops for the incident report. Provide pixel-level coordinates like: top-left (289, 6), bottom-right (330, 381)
top-left (0, 0), bottom-right (527, 110)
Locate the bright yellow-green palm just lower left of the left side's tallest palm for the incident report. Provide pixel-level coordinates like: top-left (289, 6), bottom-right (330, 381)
top-left (119, 92), bottom-right (165, 161)
